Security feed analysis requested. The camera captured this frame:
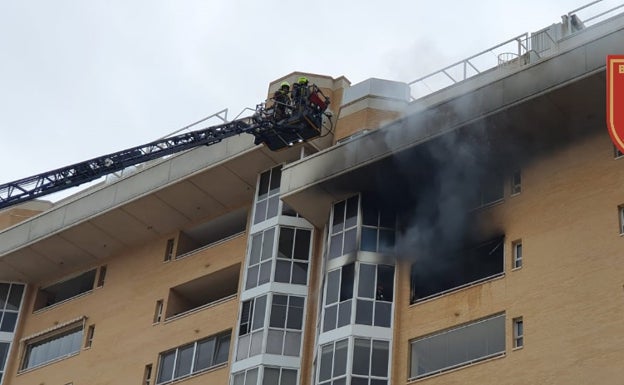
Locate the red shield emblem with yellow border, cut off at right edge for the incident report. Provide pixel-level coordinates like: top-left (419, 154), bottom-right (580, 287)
top-left (607, 55), bottom-right (624, 153)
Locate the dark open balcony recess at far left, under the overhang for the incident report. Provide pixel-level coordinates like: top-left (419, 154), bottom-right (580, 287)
top-left (34, 269), bottom-right (97, 311)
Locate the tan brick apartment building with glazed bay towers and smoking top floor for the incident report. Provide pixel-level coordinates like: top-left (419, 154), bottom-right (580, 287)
top-left (0, 3), bottom-right (624, 385)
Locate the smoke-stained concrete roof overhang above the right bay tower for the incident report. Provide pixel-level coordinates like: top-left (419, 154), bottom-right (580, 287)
top-left (281, 15), bottom-right (624, 227)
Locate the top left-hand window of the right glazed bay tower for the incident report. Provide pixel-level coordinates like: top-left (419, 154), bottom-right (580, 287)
top-left (329, 195), bottom-right (359, 259)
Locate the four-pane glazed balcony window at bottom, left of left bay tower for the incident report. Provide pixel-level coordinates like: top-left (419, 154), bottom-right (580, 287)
top-left (156, 331), bottom-right (231, 384)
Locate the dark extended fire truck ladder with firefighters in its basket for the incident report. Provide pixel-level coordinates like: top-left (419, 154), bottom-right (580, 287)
top-left (0, 84), bottom-right (332, 210)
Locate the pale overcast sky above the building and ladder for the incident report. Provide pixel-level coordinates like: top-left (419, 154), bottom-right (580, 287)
top-left (0, 0), bottom-right (622, 196)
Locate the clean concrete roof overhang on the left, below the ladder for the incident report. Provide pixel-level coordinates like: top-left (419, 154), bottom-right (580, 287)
top-left (0, 135), bottom-right (310, 282)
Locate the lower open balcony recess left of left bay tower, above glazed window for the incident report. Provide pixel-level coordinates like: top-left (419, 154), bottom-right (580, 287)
top-left (165, 264), bottom-right (240, 322)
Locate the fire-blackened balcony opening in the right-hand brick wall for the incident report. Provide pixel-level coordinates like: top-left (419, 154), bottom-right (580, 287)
top-left (410, 237), bottom-right (505, 303)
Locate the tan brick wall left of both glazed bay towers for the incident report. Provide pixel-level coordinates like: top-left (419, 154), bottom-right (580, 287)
top-left (4, 234), bottom-right (247, 385)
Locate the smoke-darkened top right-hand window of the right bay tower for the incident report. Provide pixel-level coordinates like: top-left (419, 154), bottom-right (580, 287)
top-left (360, 197), bottom-right (395, 253)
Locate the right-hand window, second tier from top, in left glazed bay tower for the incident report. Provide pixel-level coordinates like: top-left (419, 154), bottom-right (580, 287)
top-left (275, 227), bottom-right (312, 285)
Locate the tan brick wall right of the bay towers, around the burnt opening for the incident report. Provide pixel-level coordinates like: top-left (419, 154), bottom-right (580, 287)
top-left (392, 130), bottom-right (624, 385)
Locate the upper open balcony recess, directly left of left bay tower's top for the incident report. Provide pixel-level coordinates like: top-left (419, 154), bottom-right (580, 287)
top-left (174, 208), bottom-right (247, 261)
